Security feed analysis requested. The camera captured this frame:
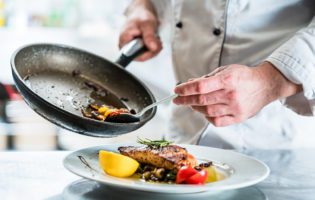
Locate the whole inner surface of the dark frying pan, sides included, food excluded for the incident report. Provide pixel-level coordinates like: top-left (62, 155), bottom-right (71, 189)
top-left (15, 45), bottom-right (153, 121)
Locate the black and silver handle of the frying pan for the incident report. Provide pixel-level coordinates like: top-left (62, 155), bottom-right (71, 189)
top-left (116, 38), bottom-right (148, 67)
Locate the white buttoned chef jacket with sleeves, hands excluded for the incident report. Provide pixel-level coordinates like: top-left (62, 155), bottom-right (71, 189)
top-left (152, 0), bottom-right (315, 149)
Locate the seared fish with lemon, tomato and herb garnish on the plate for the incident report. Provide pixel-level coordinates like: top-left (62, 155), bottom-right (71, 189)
top-left (99, 139), bottom-right (222, 184)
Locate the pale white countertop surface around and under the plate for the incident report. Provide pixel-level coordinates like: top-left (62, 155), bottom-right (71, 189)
top-left (0, 149), bottom-right (315, 200)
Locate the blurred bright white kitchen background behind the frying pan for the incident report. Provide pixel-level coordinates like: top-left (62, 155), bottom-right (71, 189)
top-left (0, 0), bottom-right (175, 150)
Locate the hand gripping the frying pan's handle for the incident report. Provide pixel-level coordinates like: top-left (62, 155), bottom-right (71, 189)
top-left (119, 0), bottom-right (162, 61)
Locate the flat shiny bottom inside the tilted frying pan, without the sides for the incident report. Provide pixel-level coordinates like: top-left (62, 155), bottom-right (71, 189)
top-left (24, 71), bottom-right (132, 115)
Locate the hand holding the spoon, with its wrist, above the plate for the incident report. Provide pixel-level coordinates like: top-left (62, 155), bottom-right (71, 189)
top-left (174, 62), bottom-right (302, 126)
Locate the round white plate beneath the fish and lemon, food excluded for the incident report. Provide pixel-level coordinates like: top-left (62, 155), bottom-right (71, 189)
top-left (64, 144), bottom-right (270, 193)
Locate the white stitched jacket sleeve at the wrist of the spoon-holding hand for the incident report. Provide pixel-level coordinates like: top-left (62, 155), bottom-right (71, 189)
top-left (267, 17), bottom-right (315, 115)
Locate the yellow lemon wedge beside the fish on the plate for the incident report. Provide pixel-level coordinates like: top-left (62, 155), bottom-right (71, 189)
top-left (99, 150), bottom-right (139, 178)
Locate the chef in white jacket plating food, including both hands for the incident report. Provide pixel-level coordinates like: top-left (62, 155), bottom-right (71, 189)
top-left (119, 0), bottom-right (315, 150)
